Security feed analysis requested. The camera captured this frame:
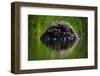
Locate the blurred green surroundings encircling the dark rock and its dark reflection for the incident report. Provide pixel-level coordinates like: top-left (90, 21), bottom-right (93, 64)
top-left (28, 15), bottom-right (88, 60)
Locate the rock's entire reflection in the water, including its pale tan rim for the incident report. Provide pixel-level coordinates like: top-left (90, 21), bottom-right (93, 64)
top-left (41, 40), bottom-right (78, 58)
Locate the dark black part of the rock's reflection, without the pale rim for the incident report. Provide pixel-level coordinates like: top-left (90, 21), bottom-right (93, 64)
top-left (42, 40), bottom-right (76, 51)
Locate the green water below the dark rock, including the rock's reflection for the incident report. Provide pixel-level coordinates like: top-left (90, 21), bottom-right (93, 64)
top-left (28, 35), bottom-right (88, 60)
